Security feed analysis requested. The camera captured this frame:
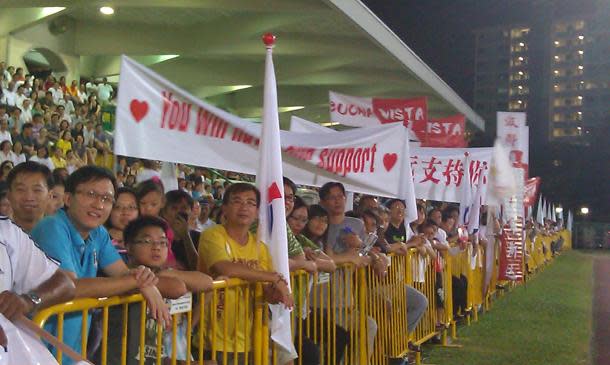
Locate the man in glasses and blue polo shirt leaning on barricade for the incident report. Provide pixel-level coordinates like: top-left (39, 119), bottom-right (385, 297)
top-left (32, 166), bottom-right (185, 364)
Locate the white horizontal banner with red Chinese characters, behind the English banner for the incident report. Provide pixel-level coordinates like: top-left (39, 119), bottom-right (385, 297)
top-left (290, 117), bottom-right (493, 205)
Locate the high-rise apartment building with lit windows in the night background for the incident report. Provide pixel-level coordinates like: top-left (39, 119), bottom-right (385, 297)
top-left (474, 7), bottom-right (610, 144)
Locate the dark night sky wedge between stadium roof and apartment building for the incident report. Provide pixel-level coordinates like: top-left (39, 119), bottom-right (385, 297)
top-left (363, 0), bottom-right (593, 106)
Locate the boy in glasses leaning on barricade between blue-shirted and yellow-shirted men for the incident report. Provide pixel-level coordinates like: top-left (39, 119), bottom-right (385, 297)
top-left (123, 216), bottom-right (212, 364)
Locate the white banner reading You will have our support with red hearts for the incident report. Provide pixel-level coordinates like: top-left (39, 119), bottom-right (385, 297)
top-left (115, 56), bottom-right (415, 206)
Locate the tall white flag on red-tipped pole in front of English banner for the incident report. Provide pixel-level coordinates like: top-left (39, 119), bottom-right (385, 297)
top-left (256, 37), bottom-right (296, 357)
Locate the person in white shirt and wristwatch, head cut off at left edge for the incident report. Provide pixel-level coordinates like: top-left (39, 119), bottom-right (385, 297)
top-left (0, 217), bottom-right (75, 346)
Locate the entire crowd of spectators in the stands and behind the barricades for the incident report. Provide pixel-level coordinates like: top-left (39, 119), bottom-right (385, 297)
top-left (0, 63), bottom-right (560, 364)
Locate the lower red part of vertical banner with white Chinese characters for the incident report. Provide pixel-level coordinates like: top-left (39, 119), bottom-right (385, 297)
top-left (498, 168), bottom-right (525, 281)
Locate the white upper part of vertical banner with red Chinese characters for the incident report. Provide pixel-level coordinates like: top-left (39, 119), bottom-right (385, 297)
top-left (497, 112), bottom-right (529, 179)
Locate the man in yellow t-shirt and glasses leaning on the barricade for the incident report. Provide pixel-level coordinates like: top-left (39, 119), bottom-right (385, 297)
top-left (198, 183), bottom-right (293, 363)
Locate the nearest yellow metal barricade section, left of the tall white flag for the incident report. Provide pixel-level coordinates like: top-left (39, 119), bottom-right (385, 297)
top-left (34, 279), bottom-right (268, 365)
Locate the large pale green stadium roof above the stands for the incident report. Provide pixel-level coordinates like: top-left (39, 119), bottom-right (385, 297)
top-left (0, 0), bottom-right (484, 129)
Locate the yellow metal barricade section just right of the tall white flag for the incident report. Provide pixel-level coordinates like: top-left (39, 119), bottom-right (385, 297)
top-left (286, 264), bottom-right (366, 365)
